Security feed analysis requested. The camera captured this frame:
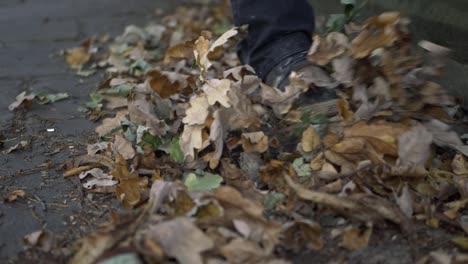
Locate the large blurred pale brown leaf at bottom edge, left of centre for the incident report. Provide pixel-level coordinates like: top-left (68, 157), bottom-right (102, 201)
top-left (145, 217), bottom-right (214, 264)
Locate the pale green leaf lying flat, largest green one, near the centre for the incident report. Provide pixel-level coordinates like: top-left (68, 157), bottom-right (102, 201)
top-left (184, 171), bottom-right (223, 192)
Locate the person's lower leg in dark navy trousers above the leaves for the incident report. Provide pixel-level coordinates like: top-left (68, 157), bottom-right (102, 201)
top-left (231, 0), bottom-right (315, 80)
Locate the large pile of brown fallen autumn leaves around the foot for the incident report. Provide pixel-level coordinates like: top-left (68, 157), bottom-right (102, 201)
top-left (59, 2), bottom-right (468, 263)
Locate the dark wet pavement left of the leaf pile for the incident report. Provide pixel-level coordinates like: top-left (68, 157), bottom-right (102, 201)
top-left (0, 0), bottom-right (174, 263)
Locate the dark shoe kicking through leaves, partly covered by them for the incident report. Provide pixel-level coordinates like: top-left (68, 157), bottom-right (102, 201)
top-left (265, 51), bottom-right (339, 116)
